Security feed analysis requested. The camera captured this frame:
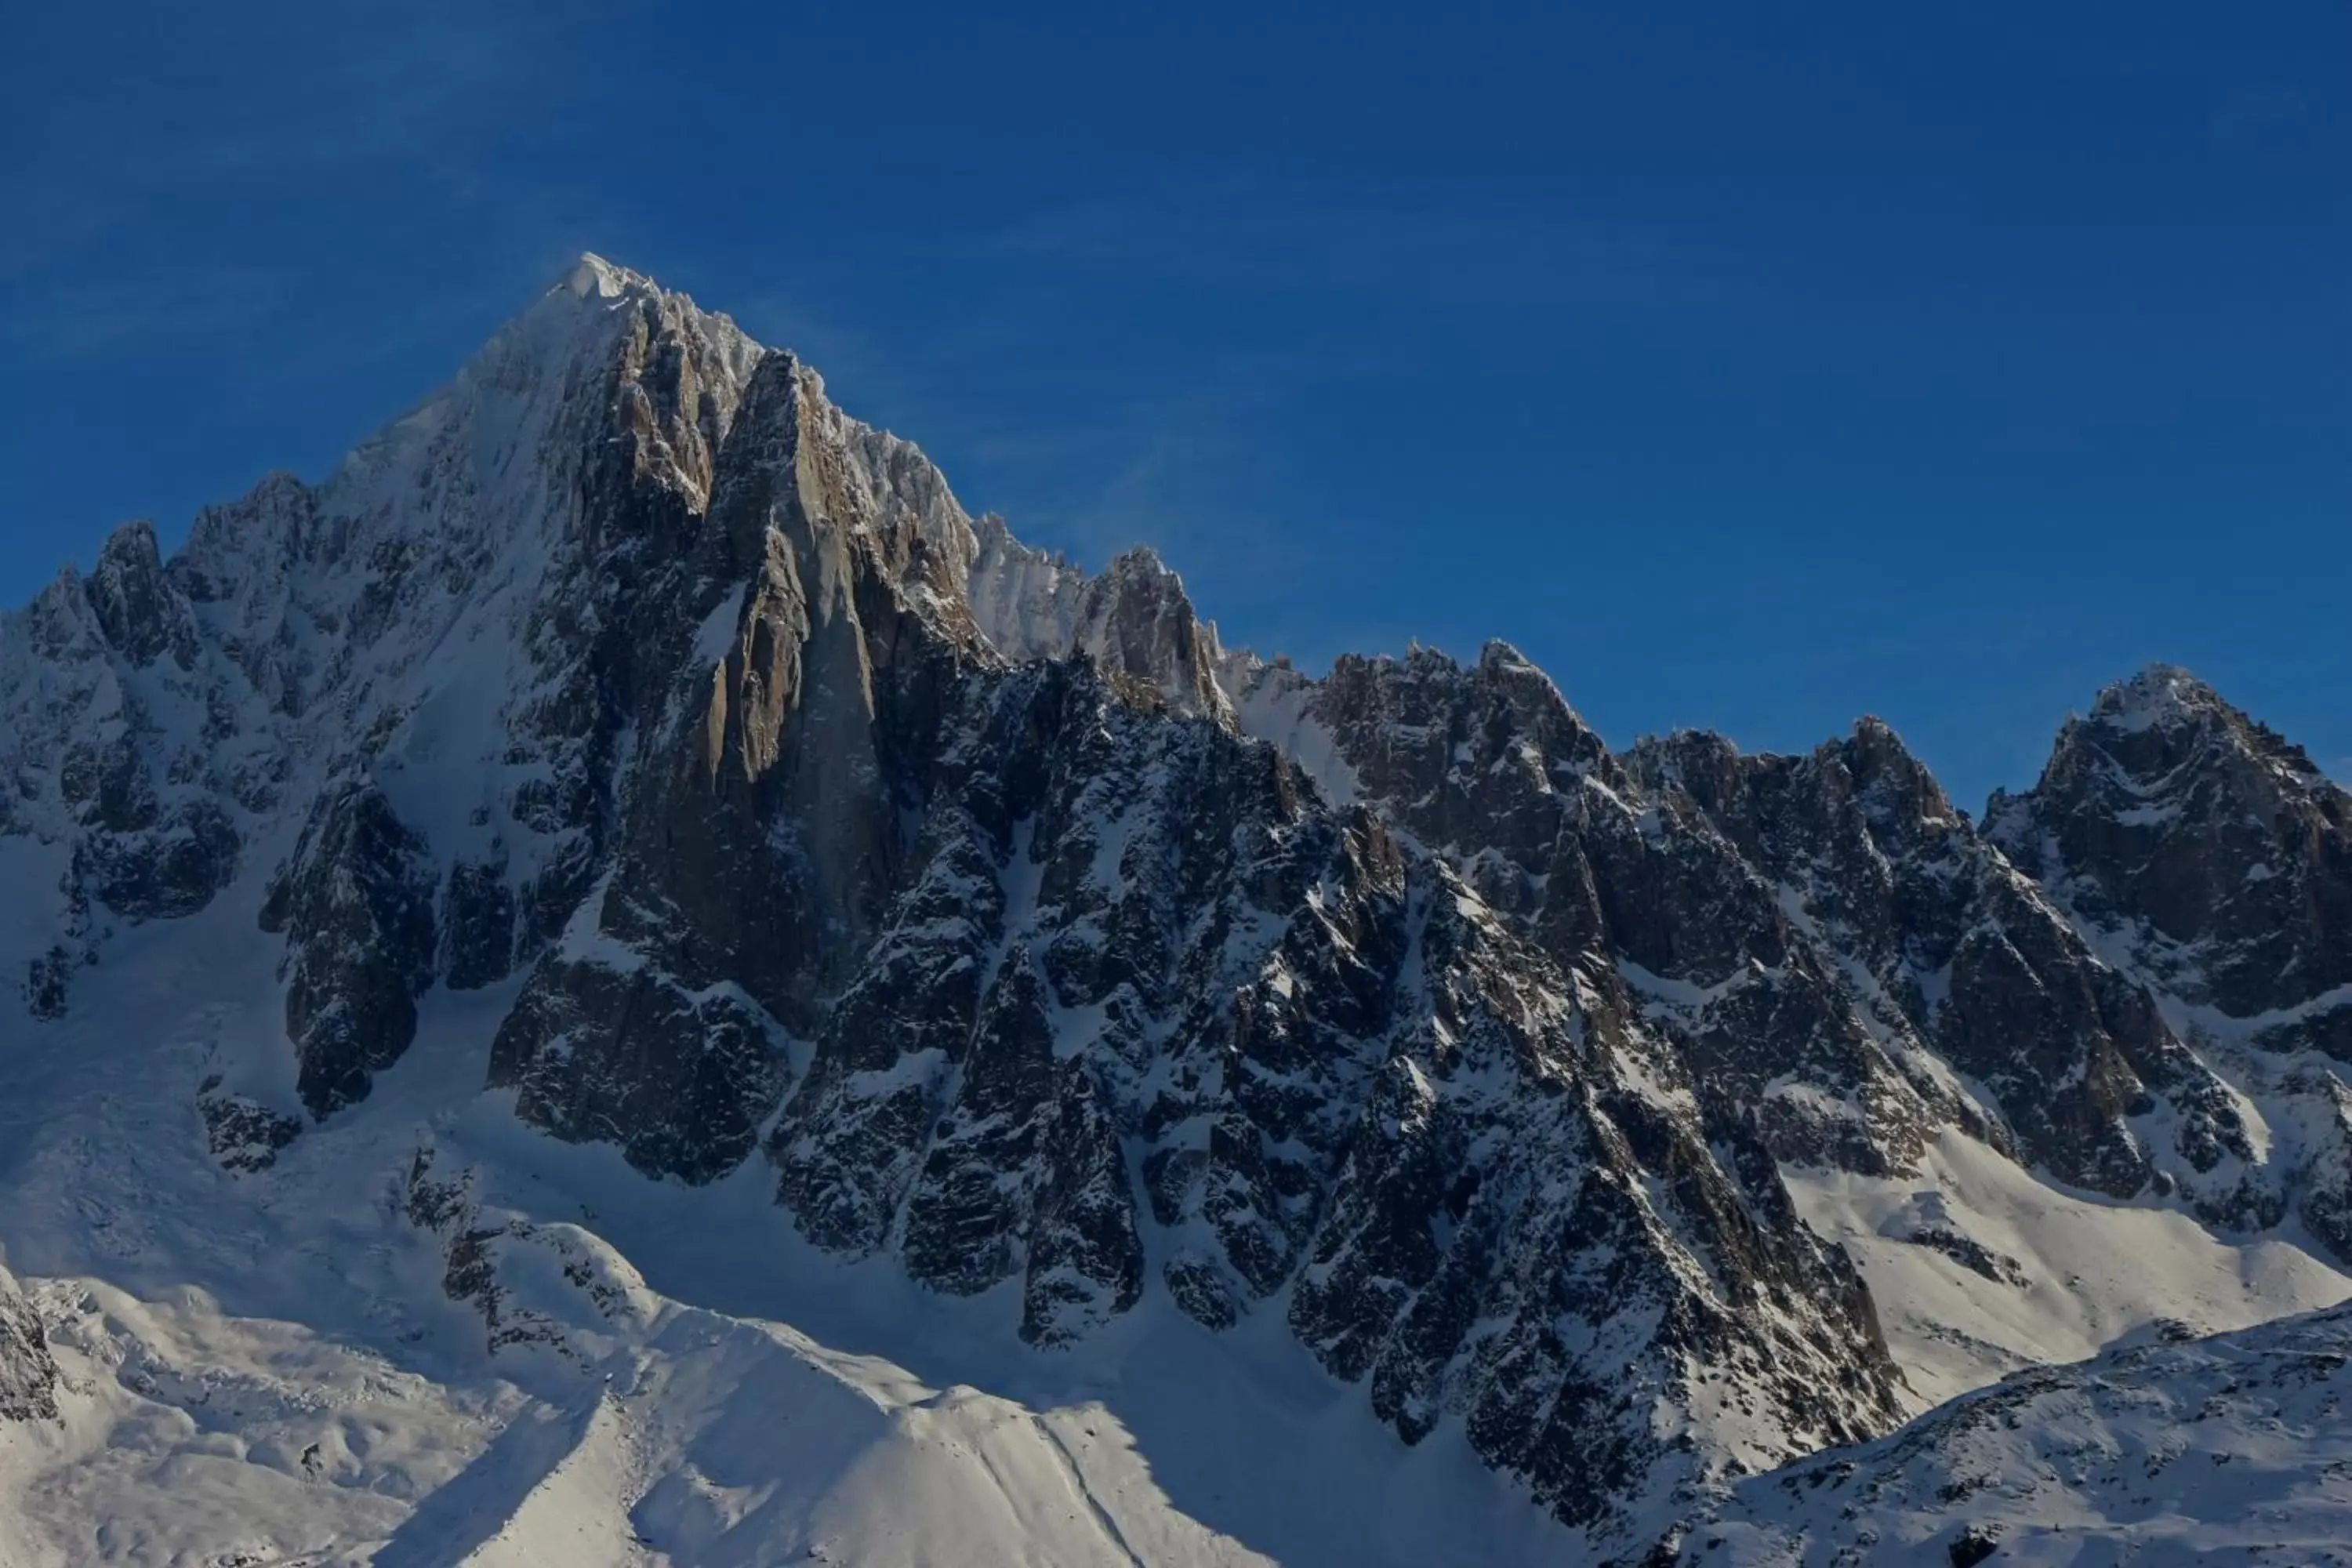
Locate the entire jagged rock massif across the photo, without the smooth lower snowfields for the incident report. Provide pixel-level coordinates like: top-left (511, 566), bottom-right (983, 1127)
top-left (0, 261), bottom-right (2352, 1549)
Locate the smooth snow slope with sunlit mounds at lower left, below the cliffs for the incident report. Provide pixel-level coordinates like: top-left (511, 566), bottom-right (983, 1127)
top-left (0, 893), bottom-right (1566, 1568)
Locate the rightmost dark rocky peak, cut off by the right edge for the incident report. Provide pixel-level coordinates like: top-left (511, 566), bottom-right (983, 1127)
top-left (1987, 666), bottom-right (2352, 1260)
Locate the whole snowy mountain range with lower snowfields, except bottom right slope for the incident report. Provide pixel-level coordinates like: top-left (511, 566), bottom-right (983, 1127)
top-left (0, 259), bottom-right (2352, 1563)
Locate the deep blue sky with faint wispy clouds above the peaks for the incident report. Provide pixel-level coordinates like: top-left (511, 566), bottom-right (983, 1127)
top-left (0, 0), bottom-right (2352, 808)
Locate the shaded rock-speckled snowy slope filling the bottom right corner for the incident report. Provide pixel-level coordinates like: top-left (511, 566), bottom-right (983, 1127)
top-left (1682, 1309), bottom-right (2352, 1568)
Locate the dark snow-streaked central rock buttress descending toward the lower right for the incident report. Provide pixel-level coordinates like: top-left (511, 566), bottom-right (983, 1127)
top-left (748, 648), bottom-right (1896, 1528)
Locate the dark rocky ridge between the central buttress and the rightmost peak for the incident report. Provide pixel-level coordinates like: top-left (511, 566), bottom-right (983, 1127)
top-left (1291, 644), bottom-right (2244, 1196)
